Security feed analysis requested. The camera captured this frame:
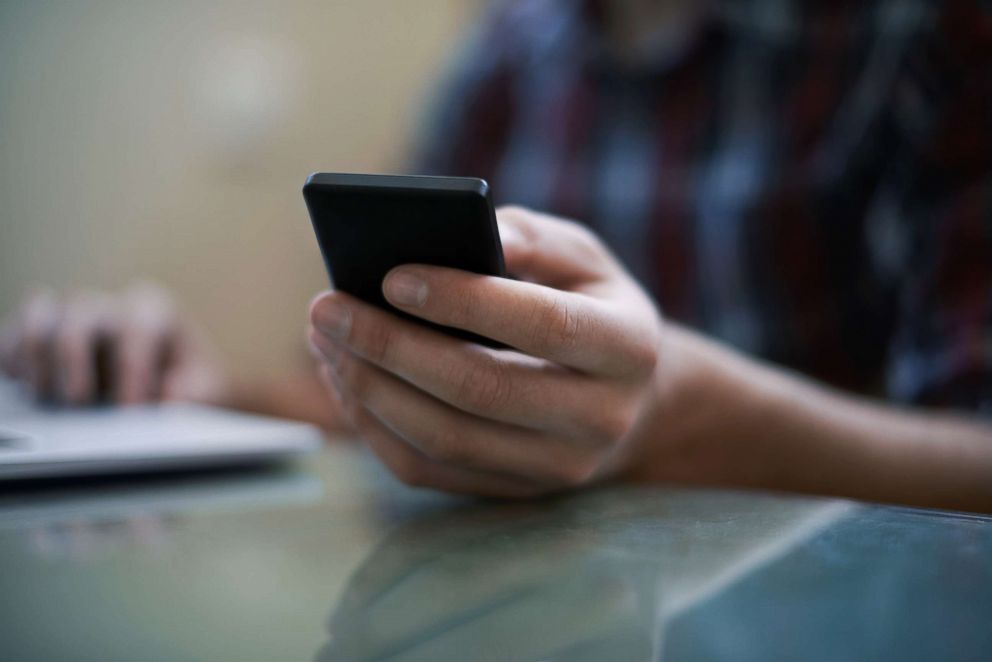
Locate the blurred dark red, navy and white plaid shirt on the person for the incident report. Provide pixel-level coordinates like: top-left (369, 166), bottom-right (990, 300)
top-left (419, 0), bottom-right (992, 413)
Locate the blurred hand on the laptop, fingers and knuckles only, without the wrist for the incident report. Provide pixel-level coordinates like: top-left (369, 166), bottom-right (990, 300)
top-left (0, 283), bottom-right (226, 405)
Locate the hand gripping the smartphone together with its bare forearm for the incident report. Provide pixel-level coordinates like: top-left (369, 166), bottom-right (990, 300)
top-left (309, 208), bottom-right (992, 510)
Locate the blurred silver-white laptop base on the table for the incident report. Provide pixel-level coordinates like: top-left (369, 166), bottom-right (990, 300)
top-left (0, 379), bottom-right (321, 481)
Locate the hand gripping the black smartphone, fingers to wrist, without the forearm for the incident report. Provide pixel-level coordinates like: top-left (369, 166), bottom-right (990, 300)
top-left (309, 208), bottom-right (662, 497)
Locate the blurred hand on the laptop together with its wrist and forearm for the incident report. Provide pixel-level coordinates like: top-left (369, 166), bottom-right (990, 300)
top-left (0, 282), bottom-right (344, 431)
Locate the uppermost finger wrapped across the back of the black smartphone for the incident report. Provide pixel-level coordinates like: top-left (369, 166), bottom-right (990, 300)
top-left (383, 265), bottom-right (655, 375)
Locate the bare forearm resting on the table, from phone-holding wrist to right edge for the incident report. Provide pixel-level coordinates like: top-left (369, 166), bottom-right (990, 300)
top-left (638, 328), bottom-right (992, 511)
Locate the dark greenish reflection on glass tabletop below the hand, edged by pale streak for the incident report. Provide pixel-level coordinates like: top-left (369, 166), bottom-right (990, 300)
top-left (317, 488), bottom-right (848, 662)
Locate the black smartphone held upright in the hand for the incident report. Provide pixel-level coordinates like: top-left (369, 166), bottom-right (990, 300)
top-left (303, 172), bottom-right (506, 347)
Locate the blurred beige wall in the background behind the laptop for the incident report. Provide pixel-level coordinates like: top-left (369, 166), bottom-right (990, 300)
top-left (0, 0), bottom-right (478, 382)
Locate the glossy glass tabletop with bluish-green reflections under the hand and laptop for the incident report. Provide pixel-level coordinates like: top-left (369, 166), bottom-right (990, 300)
top-left (0, 444), bottom-right (992, 661)
